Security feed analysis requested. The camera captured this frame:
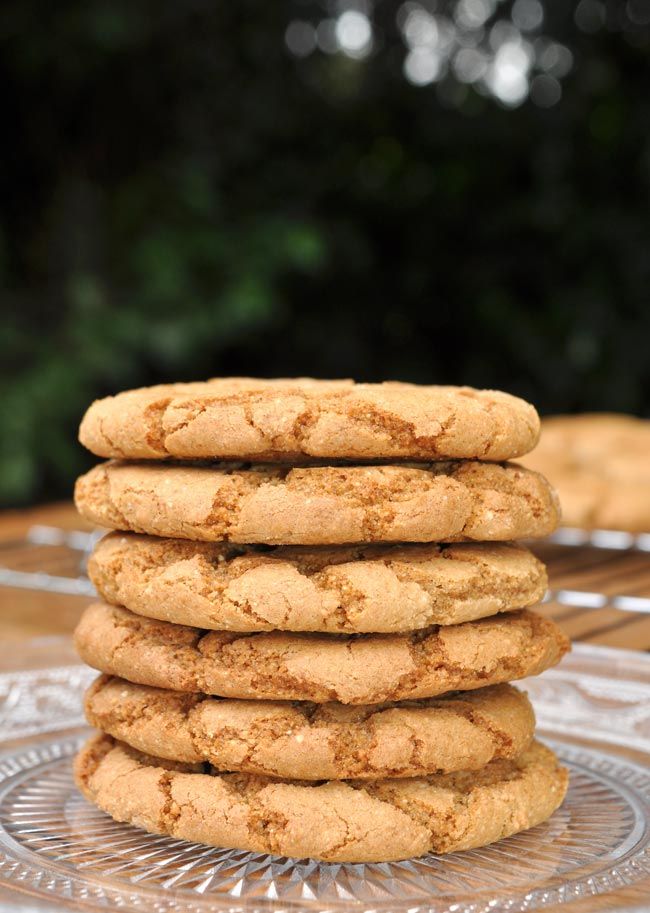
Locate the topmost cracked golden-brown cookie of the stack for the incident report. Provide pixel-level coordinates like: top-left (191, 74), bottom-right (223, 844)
top-left (79, 377), bottom-right (539, 462)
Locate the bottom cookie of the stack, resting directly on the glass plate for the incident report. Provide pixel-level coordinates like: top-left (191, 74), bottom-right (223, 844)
top-left (75, 735), bottom-right (568, 862)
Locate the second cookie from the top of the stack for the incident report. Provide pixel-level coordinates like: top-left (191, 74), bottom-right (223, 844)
top-left (75, 462), bottom-right (559, 545)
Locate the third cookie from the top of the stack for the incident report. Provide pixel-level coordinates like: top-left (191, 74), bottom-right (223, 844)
top-left (88, 533), bottom-right (547, 634)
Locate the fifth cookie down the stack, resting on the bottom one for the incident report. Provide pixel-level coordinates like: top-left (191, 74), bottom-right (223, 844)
top-left (85, 675), bottom-right (535, 780)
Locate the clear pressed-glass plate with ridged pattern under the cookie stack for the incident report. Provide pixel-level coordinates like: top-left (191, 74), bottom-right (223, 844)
top-left (0, 646), bottom-right (650, 913)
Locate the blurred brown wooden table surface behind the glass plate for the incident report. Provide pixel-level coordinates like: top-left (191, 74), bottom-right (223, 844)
top-left (0, 503), bottom-right (650, 650)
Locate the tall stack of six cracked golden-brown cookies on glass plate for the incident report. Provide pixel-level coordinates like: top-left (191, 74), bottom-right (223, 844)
top-left (76, 379), bottom-right (568, 862)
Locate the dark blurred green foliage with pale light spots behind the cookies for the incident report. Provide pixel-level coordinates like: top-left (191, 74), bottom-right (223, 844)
top-left (0, 0), bottom-right (650, 504)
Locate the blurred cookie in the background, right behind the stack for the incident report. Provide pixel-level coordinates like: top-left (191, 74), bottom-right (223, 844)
top-left (526, 414), bottom-right (650, 533)
